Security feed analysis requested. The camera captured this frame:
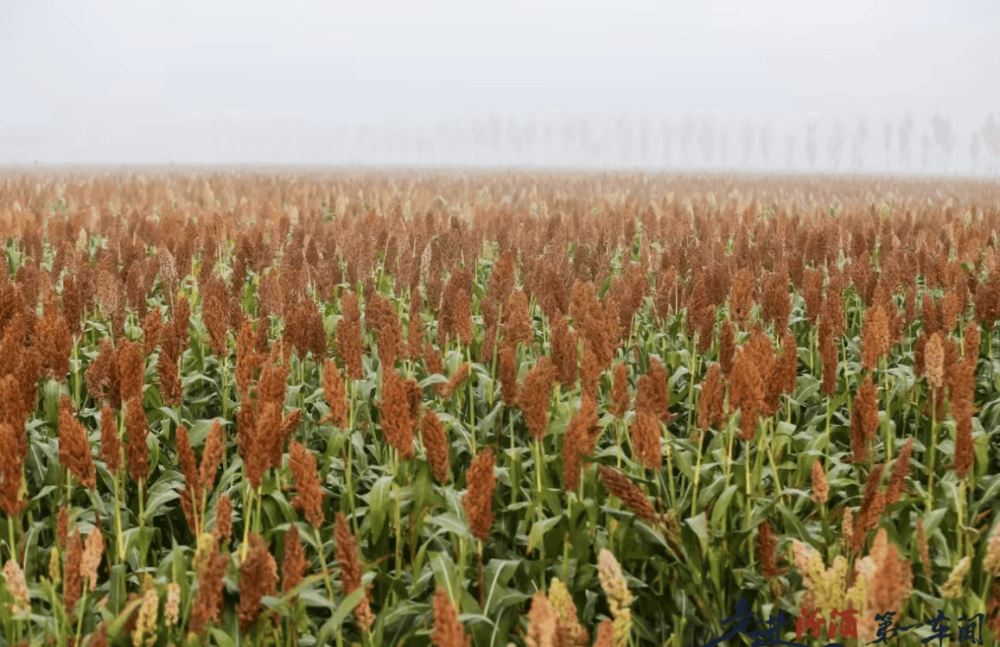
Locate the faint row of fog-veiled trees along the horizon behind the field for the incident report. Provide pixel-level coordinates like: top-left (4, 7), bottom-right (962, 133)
top-left (0, 113), bottom-right (1000, 174)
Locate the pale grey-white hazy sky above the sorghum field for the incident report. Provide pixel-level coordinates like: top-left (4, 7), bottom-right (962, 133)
top-left (0, 0), bottom-right (1000, 173)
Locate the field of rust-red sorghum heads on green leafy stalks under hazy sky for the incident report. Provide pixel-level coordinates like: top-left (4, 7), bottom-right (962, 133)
top-left (0, 168), bottom-right (1000, 647)
